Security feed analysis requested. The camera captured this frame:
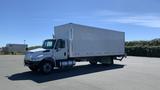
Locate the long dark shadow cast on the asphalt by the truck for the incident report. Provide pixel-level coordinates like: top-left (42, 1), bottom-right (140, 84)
top-left (6, 64), bottom-right (124, 83)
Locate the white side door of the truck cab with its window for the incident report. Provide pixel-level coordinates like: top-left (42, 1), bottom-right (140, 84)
top-left (54, 39), bottom-right (68, 60)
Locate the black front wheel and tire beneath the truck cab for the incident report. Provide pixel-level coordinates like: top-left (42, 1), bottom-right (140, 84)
top-left (40, 61), bottom-right (53, 74)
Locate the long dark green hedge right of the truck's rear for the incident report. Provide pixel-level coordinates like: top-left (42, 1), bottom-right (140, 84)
top-left (125, 39), bottom-right (160, 57)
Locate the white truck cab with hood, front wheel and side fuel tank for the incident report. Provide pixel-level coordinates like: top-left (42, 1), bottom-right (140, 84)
top-left (24, 39), bottom-right (75, 73)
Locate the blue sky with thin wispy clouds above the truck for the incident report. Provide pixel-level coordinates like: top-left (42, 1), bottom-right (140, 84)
top-left (0, 0), bottom-right (160, 47)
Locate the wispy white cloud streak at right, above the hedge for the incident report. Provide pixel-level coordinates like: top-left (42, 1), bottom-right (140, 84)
top-left (96, 11), bottom-right (160, 28)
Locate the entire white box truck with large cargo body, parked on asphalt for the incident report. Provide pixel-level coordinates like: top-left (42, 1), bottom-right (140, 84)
top-left (24, 23), bottom-right (125, 73)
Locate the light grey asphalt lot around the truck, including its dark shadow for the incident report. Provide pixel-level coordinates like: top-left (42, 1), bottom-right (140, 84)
top-left (0, 55), bottom-right (160, 90)
